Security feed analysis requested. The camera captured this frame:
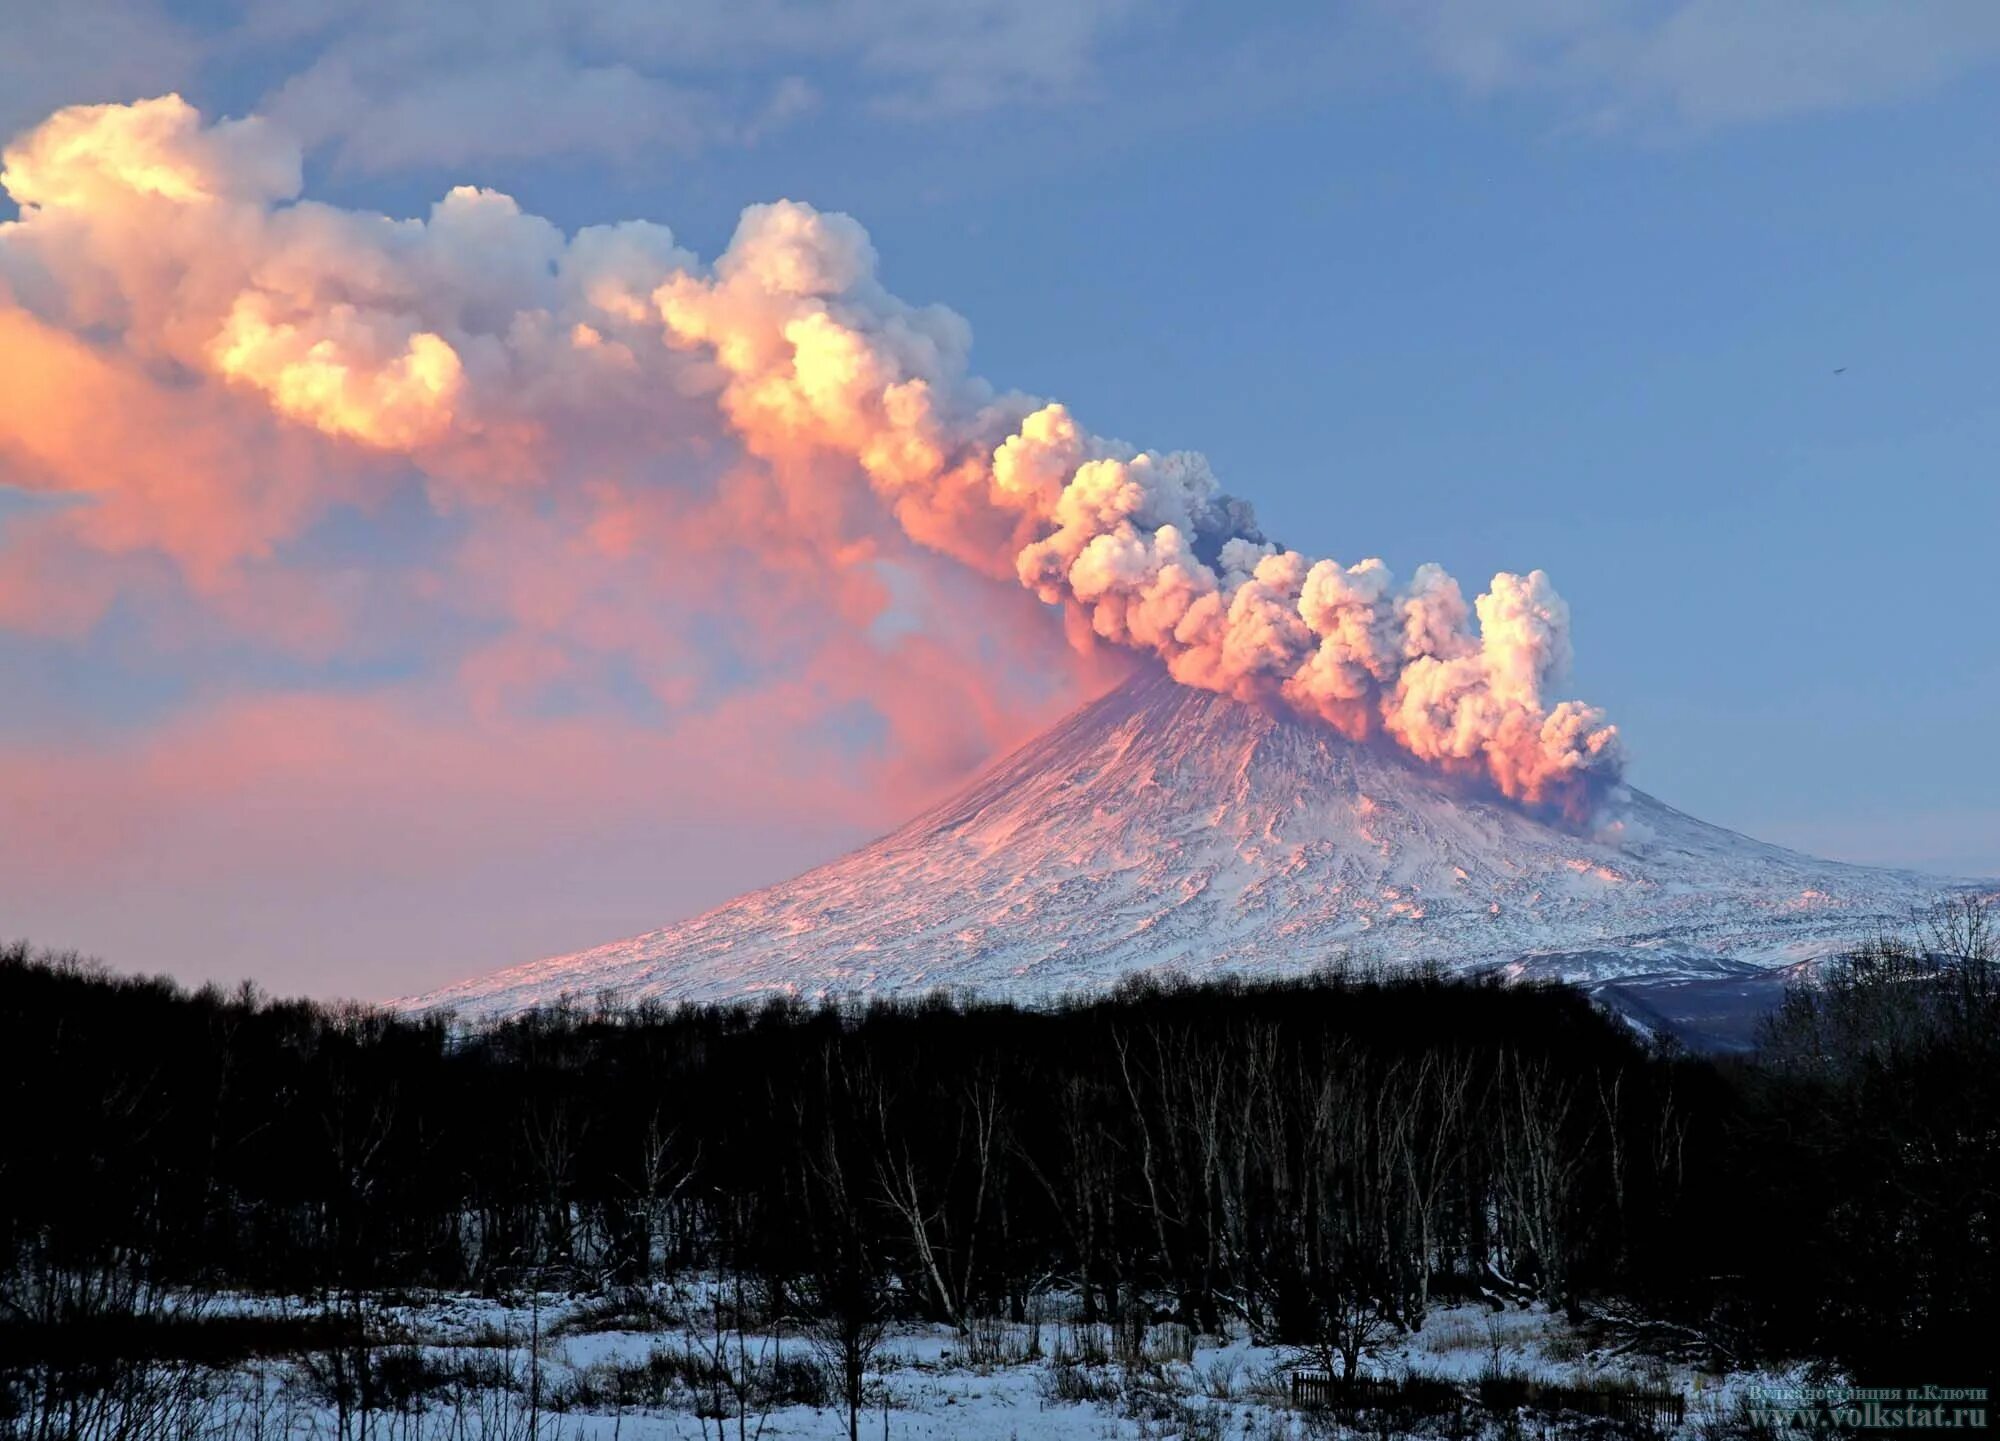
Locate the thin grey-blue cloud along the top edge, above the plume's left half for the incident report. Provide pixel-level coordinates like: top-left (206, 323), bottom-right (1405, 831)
top-left (97, 0), bottom-right (1134, 170)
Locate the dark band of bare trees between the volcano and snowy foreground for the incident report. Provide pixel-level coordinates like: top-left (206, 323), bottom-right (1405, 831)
top-left (0, 911), bottom-right (2000, 1385)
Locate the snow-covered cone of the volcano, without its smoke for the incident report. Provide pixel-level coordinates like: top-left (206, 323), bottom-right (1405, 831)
top-left (400, 674), bottom-right (1950, 1015)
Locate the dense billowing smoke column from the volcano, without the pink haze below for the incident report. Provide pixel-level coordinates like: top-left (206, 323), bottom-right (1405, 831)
top-left (0, 96), bottom-right (1622, 817)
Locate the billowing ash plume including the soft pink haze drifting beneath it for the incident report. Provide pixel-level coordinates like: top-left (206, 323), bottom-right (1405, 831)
top-left (0, 96), bottom-right (1618, 992)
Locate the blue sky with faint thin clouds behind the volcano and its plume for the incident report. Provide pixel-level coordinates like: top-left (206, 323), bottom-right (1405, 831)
top-left (0, 0), bottom-right (2000, 993)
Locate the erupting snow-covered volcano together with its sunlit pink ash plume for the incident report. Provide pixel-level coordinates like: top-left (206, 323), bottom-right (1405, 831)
top-left (0, 94), bottom-right (1976, 1032)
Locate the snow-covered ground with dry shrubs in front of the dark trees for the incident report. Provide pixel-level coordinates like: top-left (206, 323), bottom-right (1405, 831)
top-left (43, 1287), bottom-right (1832, 1441)
